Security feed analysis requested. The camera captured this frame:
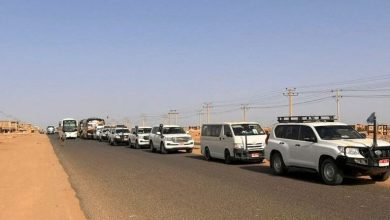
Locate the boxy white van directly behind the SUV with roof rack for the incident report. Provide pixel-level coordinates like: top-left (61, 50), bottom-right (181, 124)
top-left (200, 122), bottom-right (267, 164)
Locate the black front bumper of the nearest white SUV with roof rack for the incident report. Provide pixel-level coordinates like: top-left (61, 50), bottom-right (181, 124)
top-left (336, 156), bottom-right (390, 176)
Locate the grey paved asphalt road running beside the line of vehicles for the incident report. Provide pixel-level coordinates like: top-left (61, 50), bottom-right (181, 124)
top-left (50, 136), bottom-right (390, 220)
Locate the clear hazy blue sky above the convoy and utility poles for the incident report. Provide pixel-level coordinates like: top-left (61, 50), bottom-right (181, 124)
top-left (0, 0), bottom-right (390, 127)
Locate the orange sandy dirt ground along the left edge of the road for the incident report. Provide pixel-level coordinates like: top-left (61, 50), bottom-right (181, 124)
top-left (0, 134), bottom-right (85, 220)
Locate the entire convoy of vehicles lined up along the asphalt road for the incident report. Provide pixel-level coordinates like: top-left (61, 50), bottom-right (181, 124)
top-left (46, 116), bottom-right (390, 185)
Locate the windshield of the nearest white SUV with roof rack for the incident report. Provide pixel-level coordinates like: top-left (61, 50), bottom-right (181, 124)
top-left (315, 125), bottom-right (363, 140)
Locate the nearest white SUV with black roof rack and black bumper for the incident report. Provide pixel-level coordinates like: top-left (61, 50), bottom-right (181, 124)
top-left (265, 116), bottom-right (390, 185)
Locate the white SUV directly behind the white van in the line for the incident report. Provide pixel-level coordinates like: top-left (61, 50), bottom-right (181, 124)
top-left (149, 124), bottom-right (194, 154)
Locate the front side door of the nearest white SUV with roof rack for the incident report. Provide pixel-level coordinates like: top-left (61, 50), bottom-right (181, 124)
top-left (291, 125), bottom-right (317, 169)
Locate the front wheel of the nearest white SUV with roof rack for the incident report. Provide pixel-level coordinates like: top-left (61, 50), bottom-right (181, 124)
top-left (320, 158), bottom-right (344, 185)
